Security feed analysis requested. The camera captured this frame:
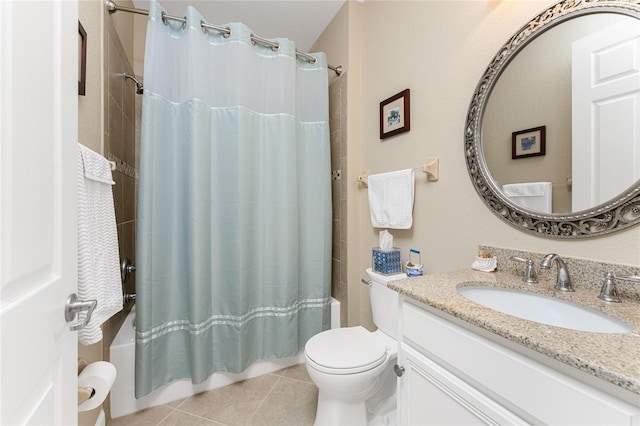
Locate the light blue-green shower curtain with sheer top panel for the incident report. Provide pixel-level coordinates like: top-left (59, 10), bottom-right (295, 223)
top-left (136, 1), bottom-right (331, 398)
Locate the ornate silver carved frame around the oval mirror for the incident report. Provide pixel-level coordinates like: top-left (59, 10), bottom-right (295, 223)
top-left (464, 0), bottom-right (640, 239)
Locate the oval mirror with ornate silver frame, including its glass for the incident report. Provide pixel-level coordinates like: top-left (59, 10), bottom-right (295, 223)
top-left (464, 0), bottom-right (640, 239)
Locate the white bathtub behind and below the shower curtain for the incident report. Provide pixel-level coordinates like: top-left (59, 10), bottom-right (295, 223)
top-left (109, 298), bottom-right (340, 419)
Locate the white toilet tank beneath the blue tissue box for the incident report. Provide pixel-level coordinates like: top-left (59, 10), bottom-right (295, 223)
top-left (367, 268), bottom-right (407, 340)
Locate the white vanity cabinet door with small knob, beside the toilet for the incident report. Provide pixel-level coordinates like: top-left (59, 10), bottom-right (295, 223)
top-left (398, 343), bottom-right (526, 425)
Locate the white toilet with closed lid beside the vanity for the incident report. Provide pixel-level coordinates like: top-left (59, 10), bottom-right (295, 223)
top-left (304, 269), bottom-right (407, 425)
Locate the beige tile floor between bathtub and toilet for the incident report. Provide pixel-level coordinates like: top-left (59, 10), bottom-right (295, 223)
top-left (109, 364), bottom-right (318, 426)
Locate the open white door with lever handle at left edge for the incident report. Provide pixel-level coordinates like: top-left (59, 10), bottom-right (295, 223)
top-left (0, 0), bottom-right (78, 425)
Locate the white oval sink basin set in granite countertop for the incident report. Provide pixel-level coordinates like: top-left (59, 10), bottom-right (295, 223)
top-left (458, 285), bottom-right (633, 333)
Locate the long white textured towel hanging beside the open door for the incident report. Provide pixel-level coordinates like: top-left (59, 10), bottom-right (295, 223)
top-left (76, 144), bottom-right (122, 345)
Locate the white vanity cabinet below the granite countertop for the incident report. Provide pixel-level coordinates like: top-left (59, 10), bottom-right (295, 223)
top-left (398, 296), bottom-right (640, 425)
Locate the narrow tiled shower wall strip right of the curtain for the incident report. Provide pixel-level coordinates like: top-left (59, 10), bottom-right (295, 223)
top-left (329, 73), bottom-right (348, 327)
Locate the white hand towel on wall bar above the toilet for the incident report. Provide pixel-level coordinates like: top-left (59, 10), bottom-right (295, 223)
top-left (367, 169), bottom-right (414, 229)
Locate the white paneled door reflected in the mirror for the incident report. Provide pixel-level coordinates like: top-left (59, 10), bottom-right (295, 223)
top-left (572, 18), bottom-right (640, 211)
